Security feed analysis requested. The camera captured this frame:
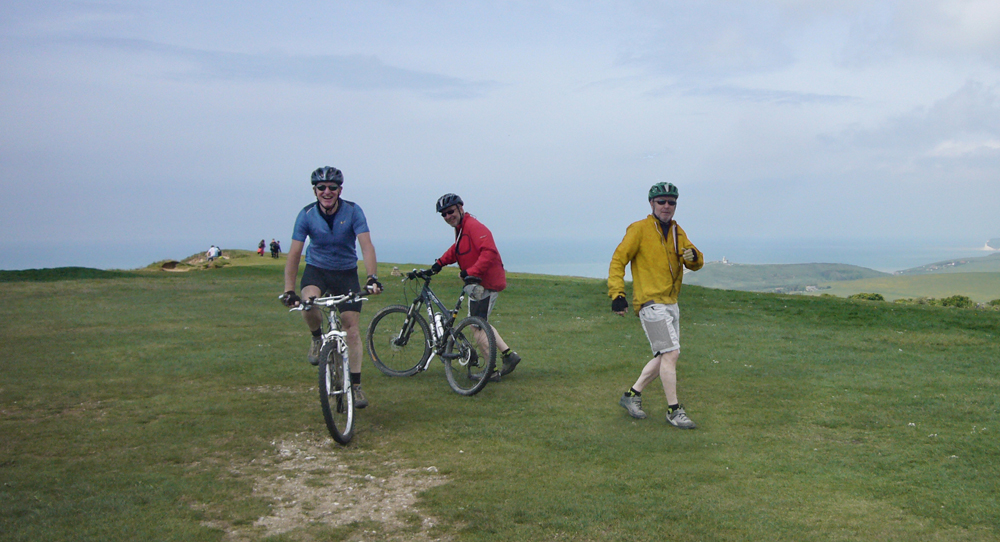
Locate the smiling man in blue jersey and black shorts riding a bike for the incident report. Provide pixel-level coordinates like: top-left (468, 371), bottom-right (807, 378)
top-left (282, 167), bottom-right (382, 408)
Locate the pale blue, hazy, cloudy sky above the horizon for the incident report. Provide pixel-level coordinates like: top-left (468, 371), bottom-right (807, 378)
top-left (0, 0), bottom-right (1000, 267)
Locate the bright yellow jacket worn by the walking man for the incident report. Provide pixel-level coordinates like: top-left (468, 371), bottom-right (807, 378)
top-left (608, 215), bottom-right (705, 313)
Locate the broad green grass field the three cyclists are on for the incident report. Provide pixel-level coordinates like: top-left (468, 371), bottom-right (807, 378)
top-left (0, 262), bottom-right (1000, 541)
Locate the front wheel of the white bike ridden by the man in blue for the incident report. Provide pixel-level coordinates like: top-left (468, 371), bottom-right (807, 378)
top-left (319, 340), bottom-right (354, 444)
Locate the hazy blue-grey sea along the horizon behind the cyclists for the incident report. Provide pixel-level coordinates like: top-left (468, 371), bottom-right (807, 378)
top-left (0, 237), bottom-right (998, 278)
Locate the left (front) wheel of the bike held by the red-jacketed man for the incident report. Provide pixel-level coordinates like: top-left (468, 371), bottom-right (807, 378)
top-left (367, 305), bottom-right (431, 376)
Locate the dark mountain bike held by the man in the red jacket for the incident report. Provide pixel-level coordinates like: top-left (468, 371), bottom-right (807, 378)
top-left (367, 269), bottom-right (497, 395)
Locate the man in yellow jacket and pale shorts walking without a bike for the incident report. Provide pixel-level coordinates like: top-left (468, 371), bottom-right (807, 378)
top-left (608, 183), bottom-right (705, 429)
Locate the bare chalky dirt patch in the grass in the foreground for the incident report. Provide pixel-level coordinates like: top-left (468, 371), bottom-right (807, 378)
top-left (225, 435), bottom-right (449, 541)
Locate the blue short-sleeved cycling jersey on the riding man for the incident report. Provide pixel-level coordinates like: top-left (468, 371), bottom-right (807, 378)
top-left (292, 199), bottom-right (369, 271)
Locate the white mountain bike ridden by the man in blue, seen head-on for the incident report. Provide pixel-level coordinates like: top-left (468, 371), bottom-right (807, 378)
top-left (279, 293), bottom-right (368, 444)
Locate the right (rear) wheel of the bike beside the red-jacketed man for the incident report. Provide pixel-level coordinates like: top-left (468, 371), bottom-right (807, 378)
top-left (442, 316), bottom-right (497, 395)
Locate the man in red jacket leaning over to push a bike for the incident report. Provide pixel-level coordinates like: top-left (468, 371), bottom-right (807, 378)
top-left (431, 194), bottom-right (521, 382)
